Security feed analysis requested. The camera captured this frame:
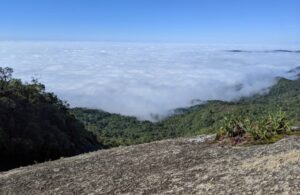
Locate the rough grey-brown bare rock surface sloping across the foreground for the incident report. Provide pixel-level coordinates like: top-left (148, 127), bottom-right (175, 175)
top-left (0, 136), bottom-right (300, 195)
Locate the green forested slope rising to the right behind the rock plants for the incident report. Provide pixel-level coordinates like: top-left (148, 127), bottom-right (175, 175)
top-left (161, 78), bottom-right (300, 133)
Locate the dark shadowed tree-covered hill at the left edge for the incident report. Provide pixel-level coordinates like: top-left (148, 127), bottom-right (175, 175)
top-left (0, 67), bottom-right (103, 170)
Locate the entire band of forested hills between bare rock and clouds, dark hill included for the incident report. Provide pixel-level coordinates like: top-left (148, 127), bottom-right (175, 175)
top-left (0, 65), bottom-right (300, 170)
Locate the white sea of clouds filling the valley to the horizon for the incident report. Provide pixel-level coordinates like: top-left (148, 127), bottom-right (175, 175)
top-left (0, 42), bottom-right (300, 119)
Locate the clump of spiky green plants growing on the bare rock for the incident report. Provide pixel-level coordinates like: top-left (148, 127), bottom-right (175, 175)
top-left (217, 110), bottom-right (290, 142)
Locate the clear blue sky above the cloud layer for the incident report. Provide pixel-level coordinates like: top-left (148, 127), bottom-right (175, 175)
top-left (0, 0), bottom-right (300, 43)
